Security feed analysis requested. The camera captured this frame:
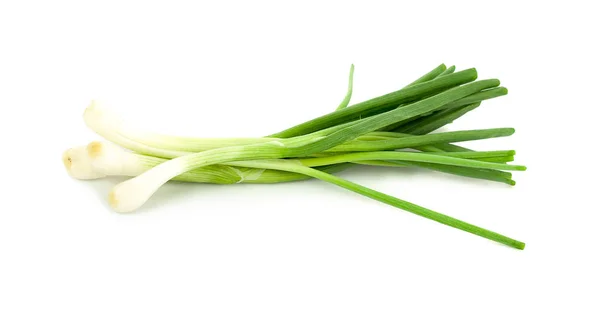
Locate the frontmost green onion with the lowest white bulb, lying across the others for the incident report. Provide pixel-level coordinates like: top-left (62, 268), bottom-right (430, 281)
top-left (96, 78), bottom-right (508, 212)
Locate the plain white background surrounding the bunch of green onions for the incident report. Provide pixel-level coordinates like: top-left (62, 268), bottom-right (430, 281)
top-left (0, 1), bottom-right (600, 314)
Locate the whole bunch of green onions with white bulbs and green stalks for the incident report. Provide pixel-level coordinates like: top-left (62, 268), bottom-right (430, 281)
top-left (63, 64), bottom-right (525, 249)
